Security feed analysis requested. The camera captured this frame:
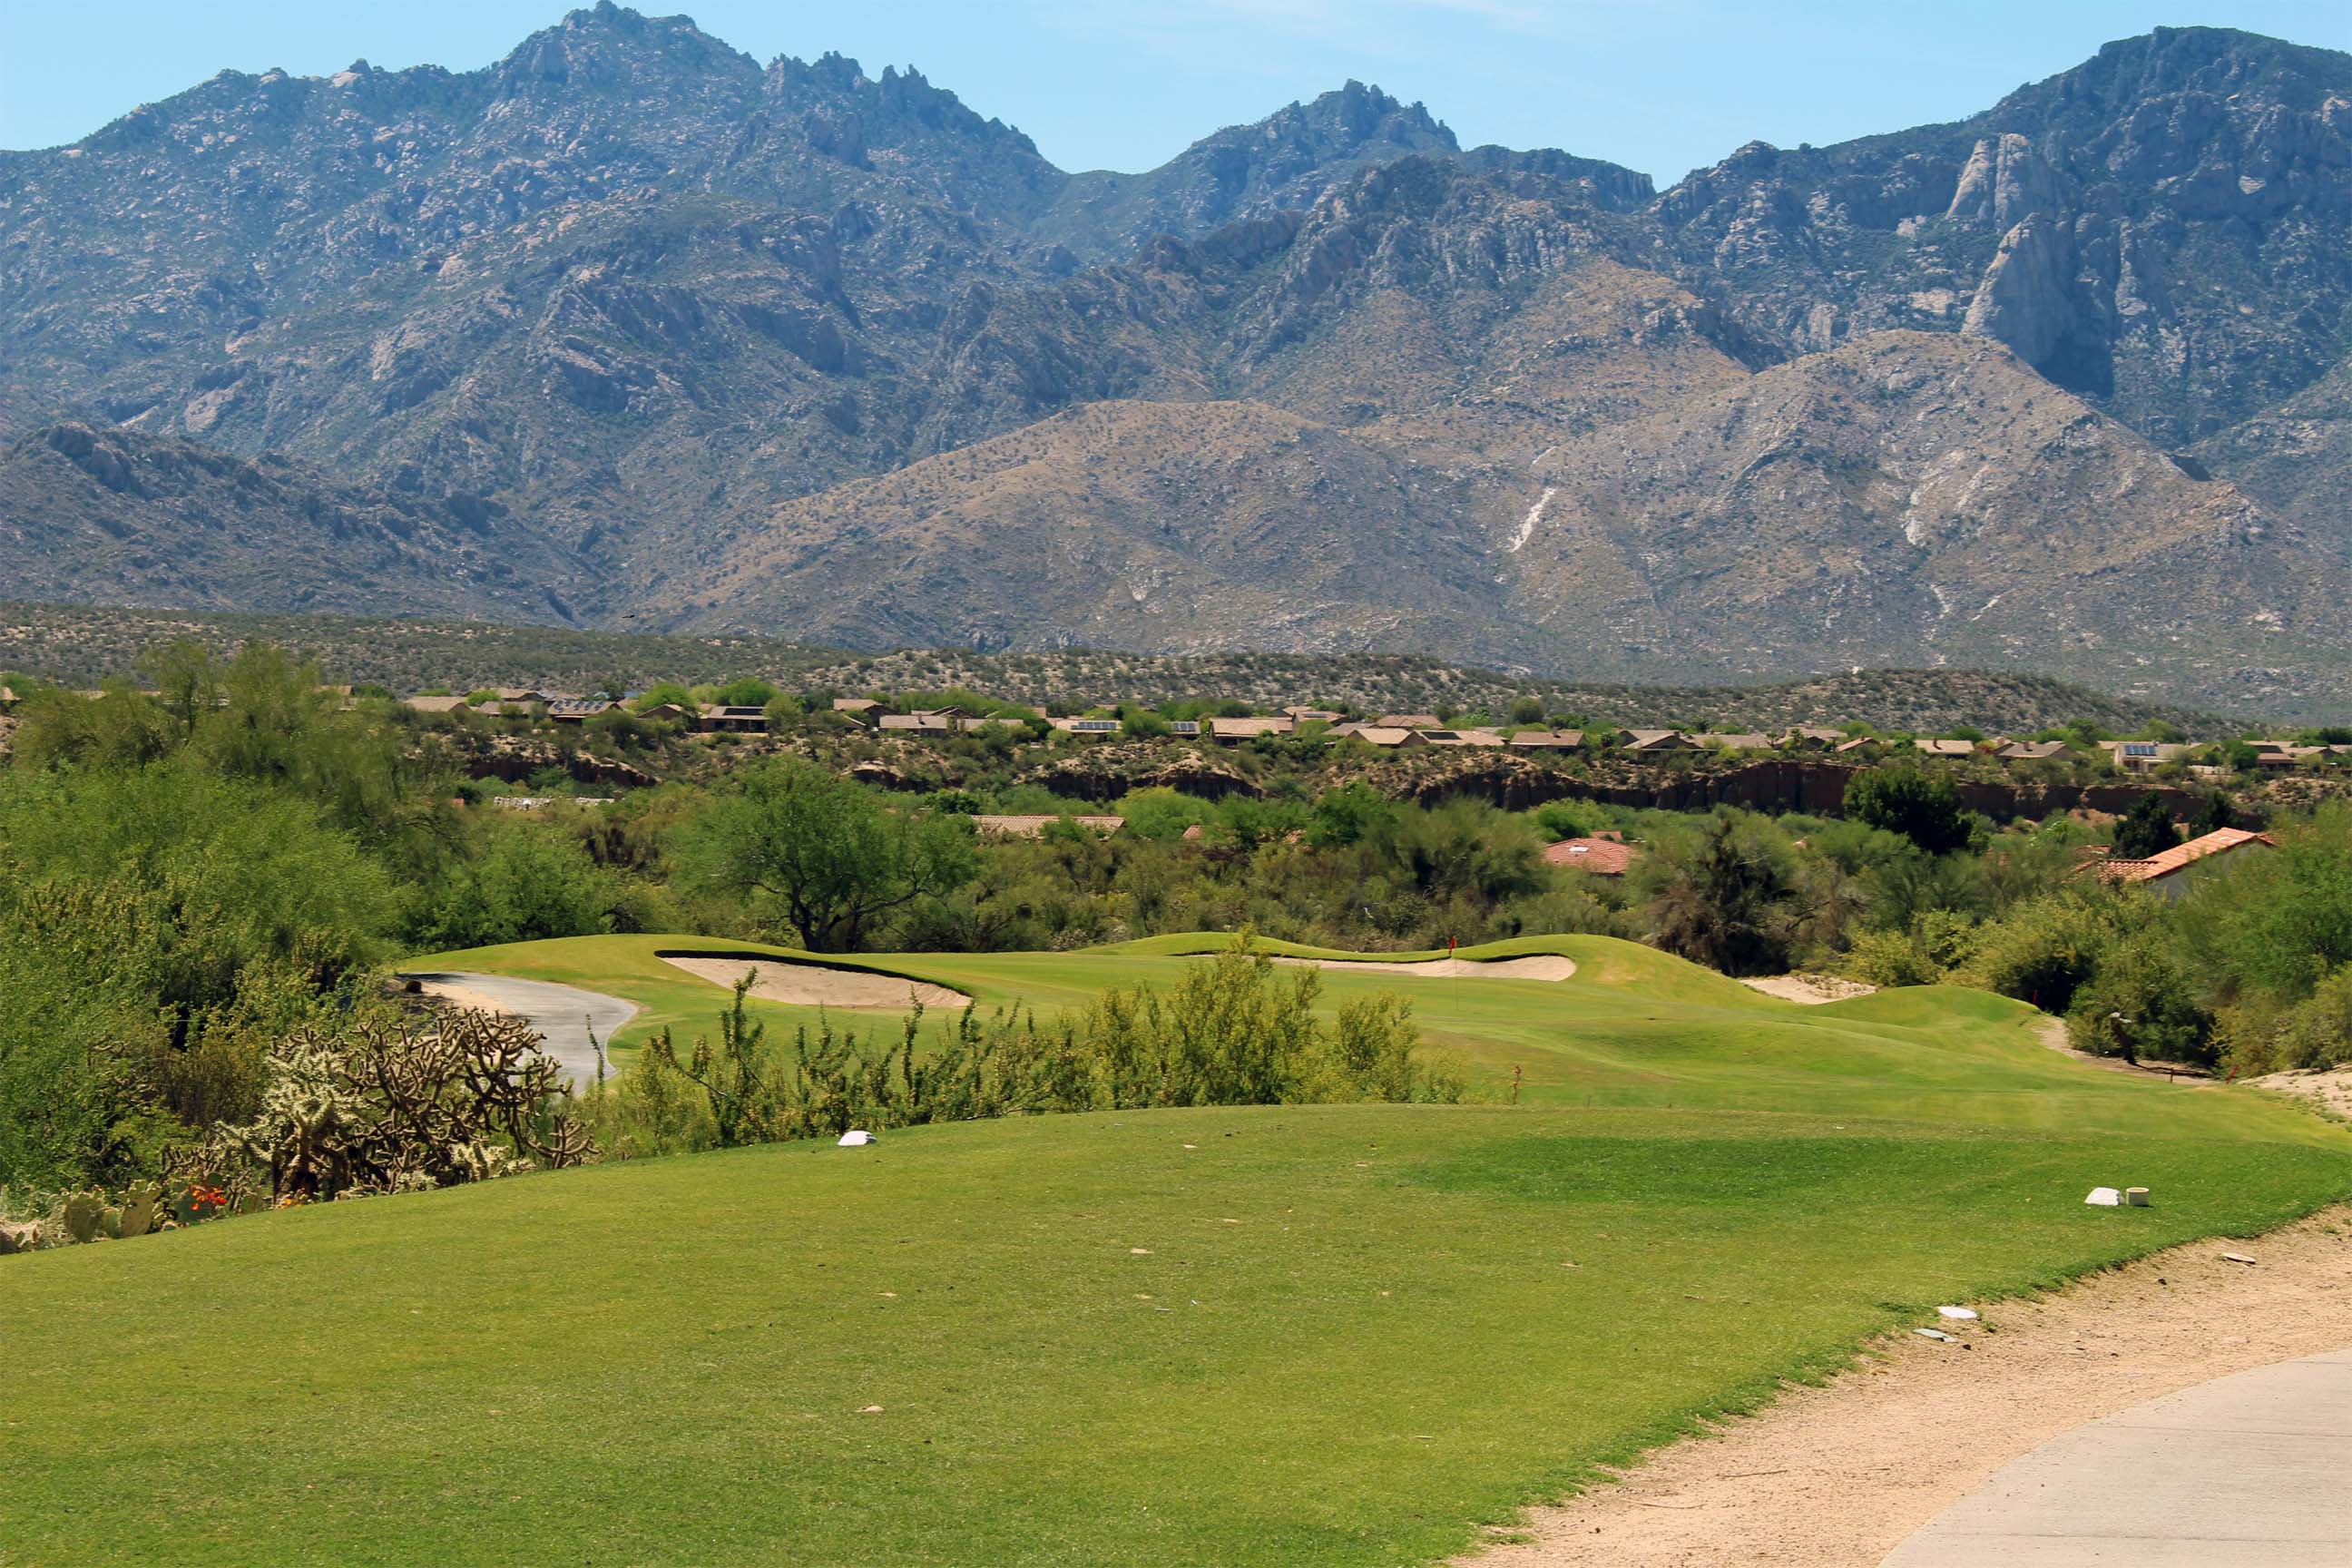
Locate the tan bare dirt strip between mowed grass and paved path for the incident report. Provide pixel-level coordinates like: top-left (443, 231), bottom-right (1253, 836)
top-left (1455, 1206), bottom-right (2352, 1568)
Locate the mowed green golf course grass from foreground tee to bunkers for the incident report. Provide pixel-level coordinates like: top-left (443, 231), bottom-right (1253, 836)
top-left (0, 938), bottom-right (2352, 1565)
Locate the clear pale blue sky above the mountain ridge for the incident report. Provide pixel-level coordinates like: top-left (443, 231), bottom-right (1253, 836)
top-left (0, 0), bottom-right (2352, 186)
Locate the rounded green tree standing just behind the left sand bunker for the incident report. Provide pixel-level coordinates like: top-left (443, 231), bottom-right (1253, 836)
top-left (680, 757), bottom-right (976, 952)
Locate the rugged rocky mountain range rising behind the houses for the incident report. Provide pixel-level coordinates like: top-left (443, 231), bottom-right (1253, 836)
top-left (0, 5), bottom-right (2352, 708)
